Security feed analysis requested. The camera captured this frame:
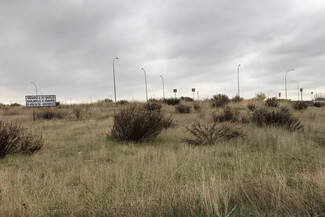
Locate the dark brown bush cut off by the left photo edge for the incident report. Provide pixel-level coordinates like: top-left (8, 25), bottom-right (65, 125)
top-left (0, 121), bottom-right (43, 158)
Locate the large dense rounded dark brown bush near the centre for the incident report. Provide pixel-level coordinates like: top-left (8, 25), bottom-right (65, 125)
top-left (108, 105), bottom-right (172, 143)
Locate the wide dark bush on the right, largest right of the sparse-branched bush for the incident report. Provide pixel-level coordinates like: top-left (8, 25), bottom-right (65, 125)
top-left (251, 108), bottom-right (303, 132)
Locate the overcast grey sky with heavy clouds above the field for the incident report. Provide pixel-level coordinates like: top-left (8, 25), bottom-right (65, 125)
top-left (0, 0), bottom-right (325, 103)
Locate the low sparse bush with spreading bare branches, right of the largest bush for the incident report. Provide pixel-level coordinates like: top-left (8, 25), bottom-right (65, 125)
top-left (183, 122), bottom-right (245, 145)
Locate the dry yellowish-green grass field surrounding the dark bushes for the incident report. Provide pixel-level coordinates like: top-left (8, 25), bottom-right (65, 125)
top-left (0, 100), bottom-right (325, 217)
